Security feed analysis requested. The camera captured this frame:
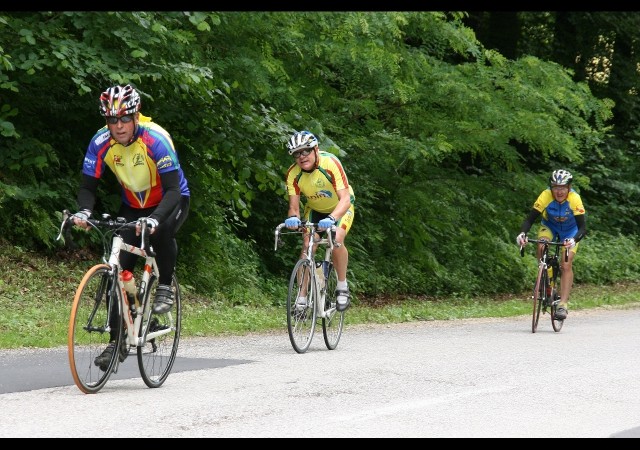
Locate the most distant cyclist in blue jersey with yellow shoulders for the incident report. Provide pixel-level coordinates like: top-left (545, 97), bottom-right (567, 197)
top-left (516, 169), bottom-right (587, 320)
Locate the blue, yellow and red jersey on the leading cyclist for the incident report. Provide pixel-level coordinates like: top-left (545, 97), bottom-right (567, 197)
top-left (82, 114), bottom-right (189, 209)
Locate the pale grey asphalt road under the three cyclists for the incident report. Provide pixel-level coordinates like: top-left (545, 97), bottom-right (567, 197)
top-left (0, 308), bottom-right (640, 438)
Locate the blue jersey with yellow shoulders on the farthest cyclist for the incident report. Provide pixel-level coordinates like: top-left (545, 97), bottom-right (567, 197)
top-left (533, 188), bottom-right (585, 236)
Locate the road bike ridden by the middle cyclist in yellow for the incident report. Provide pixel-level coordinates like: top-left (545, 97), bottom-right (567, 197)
top-left (275, 222), bottom-right (345, 353)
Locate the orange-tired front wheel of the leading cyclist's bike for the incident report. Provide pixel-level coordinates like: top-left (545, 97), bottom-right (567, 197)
top-left (67, 264), bottom-right (122, 394)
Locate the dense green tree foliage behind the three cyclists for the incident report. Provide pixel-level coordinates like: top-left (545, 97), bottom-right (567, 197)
top-left (0, 11), bottom-right (640, 305)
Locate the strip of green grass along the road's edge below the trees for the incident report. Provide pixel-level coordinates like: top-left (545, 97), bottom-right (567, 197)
top-left (0, 246), bottom-right (640, 349)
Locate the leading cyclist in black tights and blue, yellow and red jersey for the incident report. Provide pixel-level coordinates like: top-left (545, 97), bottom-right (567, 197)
top-left (74, 84), bottom-right (190, 370)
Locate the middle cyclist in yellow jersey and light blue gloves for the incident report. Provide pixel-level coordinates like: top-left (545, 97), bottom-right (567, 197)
top-left (285, 131), bottom-right (355, 311)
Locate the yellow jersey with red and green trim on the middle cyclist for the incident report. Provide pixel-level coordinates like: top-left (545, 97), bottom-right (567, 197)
top-left (286, 151), bottom-right (355, 214)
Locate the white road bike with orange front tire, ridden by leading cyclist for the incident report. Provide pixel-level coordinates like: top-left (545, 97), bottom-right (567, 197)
top-left (57, 210), bottom-right (182, 394)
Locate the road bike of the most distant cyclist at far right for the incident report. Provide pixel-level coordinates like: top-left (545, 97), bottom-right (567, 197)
top-left (520, 236), bottom-right (569, 333)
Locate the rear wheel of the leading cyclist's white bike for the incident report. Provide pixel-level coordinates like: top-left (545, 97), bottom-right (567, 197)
top-left (137, 274), bottom-right (182, 388)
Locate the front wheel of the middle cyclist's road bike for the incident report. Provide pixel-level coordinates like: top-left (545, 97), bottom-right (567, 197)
top-left (287, 259), bottom-right (318, 353)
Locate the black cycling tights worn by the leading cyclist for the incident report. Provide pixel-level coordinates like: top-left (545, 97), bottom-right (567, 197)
top-left (118, 195), bottom-right (190, 285)
